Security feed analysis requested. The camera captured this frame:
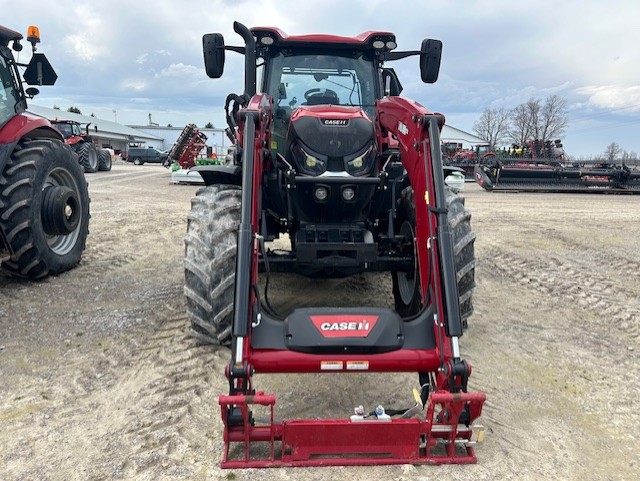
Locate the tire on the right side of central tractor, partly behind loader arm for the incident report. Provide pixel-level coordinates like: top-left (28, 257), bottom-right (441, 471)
top-left (392, 187), bottom-right (476, 328)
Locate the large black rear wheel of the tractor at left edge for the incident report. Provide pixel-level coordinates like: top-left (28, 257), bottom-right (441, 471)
top-left (0, 139), bottom-right (90, 280)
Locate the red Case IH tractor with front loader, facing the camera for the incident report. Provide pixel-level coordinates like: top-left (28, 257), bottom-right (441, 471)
top-left (185, 22), bottom-right (485, 468)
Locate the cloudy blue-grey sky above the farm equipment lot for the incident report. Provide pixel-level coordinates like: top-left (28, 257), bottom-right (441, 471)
top-left (6, 0), bottom-right (640, 158)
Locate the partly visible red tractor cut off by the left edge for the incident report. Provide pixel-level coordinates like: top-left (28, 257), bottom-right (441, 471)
top-left (0, 26), bottom-right (89, 279)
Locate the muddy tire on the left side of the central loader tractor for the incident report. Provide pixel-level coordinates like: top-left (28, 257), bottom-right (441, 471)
top-left (184, 185), bottom-right (242, 346)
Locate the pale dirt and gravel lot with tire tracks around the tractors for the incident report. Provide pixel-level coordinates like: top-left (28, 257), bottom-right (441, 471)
top-left (0, 164), bottom-right (640, 481)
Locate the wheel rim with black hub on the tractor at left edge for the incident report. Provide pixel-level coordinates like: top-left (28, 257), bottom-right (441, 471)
top-left (41, 168), bottom-right (84, 255)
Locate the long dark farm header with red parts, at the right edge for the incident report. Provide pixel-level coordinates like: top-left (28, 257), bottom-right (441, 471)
top-left (474, 140), bottom-right (640, 194)
